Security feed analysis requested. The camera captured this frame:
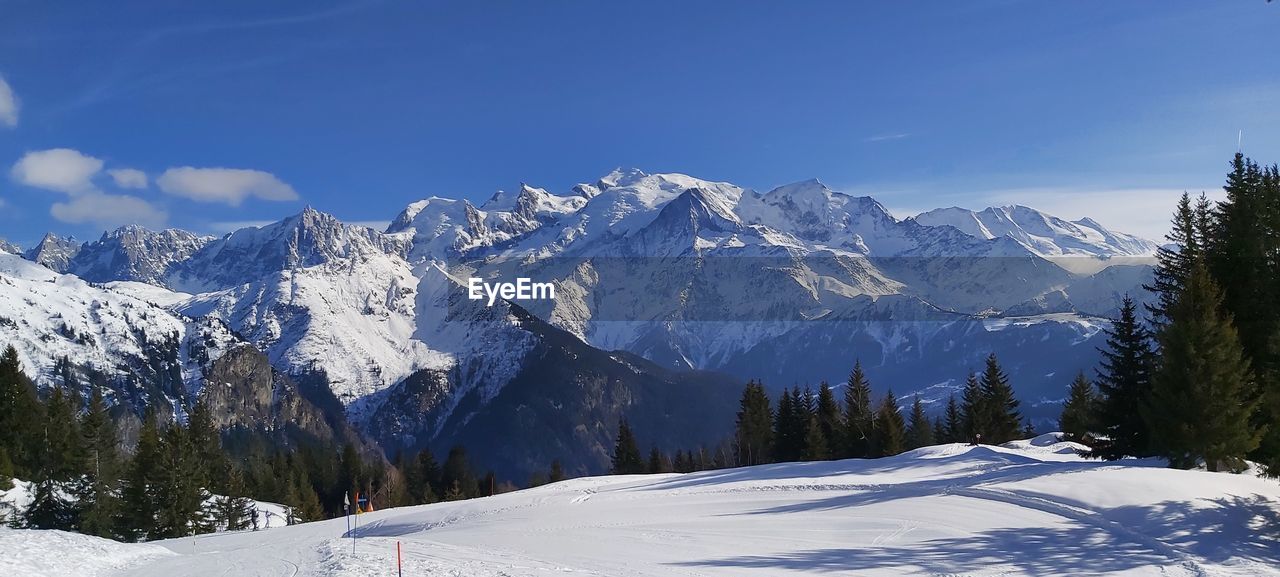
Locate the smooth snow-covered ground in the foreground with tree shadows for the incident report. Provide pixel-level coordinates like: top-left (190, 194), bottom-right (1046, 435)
top-left (0, 436), bottom-right (1280, 577)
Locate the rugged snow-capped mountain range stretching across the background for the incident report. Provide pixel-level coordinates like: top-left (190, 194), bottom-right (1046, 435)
top-left (0, 170), bottom-right (1157, 476)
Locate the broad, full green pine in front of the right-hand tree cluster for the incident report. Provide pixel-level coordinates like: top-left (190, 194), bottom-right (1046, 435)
top-left (1142, 261), bottom-right (1262, 471)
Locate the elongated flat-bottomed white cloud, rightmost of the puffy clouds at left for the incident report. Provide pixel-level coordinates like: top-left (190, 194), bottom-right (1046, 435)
top-left (156, 166), bottom-right (298, 206)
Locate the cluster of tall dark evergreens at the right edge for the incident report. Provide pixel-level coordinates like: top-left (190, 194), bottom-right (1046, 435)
top-left (1061, 154), bottom-right (1280, 475)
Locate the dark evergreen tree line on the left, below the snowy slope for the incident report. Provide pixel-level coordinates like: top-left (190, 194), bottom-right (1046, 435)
top-left (0, 347), bottom-right (498, 541)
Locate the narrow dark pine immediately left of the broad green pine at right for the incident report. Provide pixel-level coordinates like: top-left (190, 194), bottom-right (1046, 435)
top-left (1089, 296), bottom-right (1155, 459)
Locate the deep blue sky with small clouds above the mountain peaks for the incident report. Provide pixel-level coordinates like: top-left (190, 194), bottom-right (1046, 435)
top-left (0, 0), bottom-right (1280, 246)
